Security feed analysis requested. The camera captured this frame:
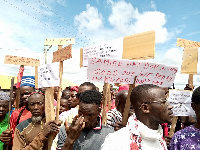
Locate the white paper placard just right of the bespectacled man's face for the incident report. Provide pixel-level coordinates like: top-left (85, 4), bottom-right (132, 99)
top-left (168, 90), bottom-right (195, 116)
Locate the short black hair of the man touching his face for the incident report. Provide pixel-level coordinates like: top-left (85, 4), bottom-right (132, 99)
top-left (80, 90), bottom-right (102, 106)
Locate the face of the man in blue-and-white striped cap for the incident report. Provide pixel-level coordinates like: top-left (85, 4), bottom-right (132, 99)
top-left (20, 86), bottom-right (33, 105)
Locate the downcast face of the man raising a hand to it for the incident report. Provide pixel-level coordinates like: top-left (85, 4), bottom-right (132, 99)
top-left (78, 102), bottom-right (101, 129)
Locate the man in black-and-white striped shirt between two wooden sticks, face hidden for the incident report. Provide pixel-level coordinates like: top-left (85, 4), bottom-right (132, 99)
top-left (107, 90), bottom-right (128, 127)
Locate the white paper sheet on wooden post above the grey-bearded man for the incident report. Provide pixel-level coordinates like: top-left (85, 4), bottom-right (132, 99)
top-left (38, 62), bottom-right (60, 88)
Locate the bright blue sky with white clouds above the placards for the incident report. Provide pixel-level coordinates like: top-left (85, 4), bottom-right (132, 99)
top-left (0, 0), bottom-right (200, 89)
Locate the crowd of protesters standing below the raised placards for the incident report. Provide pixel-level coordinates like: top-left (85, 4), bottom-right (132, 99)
top-left (0, 76), bottom-right (200, 150)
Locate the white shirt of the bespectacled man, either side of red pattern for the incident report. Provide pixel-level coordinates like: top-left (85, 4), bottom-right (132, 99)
top-left (101, 121), bottom-right (167, 150)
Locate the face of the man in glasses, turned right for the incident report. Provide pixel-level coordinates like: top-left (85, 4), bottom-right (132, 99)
top-left (147, 88), bottom-right (173, 123)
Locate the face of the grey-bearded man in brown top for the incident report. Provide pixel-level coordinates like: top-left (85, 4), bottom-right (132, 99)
top-left (28, 93), bottom-right (45, 117)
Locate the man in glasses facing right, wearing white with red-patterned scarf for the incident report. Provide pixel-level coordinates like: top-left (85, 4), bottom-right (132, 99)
top-left (102, 84), bottom-right (173, 150)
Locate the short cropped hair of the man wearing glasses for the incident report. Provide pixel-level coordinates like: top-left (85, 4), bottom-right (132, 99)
top-left (130, 84), bottom-right (160, 109)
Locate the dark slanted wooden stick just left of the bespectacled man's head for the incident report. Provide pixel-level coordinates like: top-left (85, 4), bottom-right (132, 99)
top-left (122, 76), bottom-right (137, 125)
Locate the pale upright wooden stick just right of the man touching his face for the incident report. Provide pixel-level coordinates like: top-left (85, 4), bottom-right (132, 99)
top-left (102, 83), bottom-right (109, 125)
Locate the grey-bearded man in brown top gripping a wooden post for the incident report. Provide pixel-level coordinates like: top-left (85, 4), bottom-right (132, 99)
top-left (13, 91), bottom-right (59, 150)
